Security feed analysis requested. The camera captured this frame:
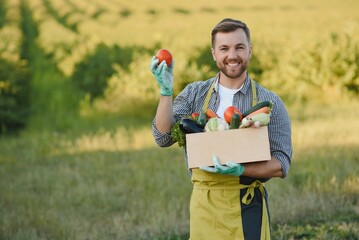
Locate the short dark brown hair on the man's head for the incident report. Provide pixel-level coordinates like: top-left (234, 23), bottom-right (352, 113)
top-left (211, 18), bottom-right (251, 47)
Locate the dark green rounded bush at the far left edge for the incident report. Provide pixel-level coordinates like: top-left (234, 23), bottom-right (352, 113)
top-left (0, 59), bottom-right (30, 134)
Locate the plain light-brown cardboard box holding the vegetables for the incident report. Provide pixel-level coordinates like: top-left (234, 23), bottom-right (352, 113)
top-left (186, 126), bottom-right (271, 168)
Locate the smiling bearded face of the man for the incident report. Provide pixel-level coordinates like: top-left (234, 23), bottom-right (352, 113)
top-left (211, 29), bottom-right (252, 78)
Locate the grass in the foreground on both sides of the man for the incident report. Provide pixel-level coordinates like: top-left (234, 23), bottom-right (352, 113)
top-left (0, 104), bottom-right (359, 240)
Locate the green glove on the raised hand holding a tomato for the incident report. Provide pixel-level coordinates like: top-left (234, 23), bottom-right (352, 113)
top-left (150, 57), bottom-right (174, 96)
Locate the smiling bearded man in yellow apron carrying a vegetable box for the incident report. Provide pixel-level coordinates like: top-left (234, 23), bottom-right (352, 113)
top-left (151, 18), bottom-right (292, 240)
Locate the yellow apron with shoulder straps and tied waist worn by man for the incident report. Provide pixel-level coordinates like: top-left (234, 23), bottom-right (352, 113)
top-left (190, 80), bottom-right (270, 240)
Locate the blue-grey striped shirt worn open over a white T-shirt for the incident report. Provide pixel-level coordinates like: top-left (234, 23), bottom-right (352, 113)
top-left (152, 74), bottom-right (292, 177)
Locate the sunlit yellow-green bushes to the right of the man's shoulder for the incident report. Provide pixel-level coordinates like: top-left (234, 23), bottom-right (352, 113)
top-left (263, 24), bottom-right (359, 104)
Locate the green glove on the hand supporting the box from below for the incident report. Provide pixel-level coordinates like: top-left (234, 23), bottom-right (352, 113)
top-left (199, 156), bottom-right (244, 177)
